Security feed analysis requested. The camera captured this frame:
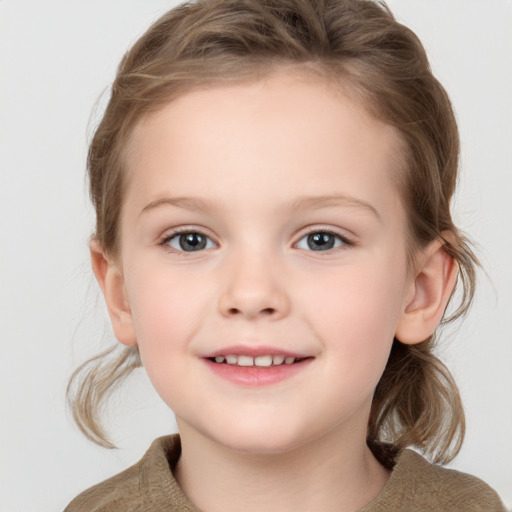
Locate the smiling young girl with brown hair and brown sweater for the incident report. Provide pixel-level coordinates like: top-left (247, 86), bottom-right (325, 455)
top-left (66, 0), bottom-right (504, 512)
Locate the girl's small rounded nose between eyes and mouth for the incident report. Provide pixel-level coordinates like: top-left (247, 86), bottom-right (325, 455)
top-left (219, 249), bottom-right (290, 320)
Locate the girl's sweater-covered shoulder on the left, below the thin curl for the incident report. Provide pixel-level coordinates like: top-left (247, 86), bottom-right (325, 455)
top-left (64, 435), bottom-right (197, 512)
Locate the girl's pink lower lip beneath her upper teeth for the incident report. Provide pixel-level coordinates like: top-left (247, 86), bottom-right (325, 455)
top-left (204, 358), bottom-right (313, 387)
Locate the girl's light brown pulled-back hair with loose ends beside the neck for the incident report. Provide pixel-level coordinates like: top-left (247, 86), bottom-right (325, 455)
top-left (68, 0), bottom-right (477, 462)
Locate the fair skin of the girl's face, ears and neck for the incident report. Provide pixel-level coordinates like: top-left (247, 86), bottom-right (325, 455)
top-left (91, 72), bottom-right (456, 512)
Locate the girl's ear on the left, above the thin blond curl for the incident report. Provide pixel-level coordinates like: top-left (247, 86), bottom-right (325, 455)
top-left (89, 240), bottom-right (137, 346)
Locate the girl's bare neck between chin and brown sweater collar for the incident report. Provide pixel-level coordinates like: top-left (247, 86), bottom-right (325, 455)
top-left (176, 426), bottom-right (389, 512)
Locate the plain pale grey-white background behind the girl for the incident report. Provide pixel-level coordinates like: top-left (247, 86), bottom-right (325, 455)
top-left (0, 0), bottom-right (512, 512)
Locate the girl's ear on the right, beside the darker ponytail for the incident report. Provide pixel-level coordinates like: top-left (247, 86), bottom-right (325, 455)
top-left (395, 235), bottom-right (458, 345)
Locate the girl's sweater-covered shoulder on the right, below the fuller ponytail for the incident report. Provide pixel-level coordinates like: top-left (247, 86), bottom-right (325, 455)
top-left (363, 450), bottom-right (505, 512)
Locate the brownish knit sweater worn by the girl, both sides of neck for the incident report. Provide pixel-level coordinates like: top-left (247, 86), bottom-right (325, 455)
top-left (64, 435), bottom-right (505, 512)
